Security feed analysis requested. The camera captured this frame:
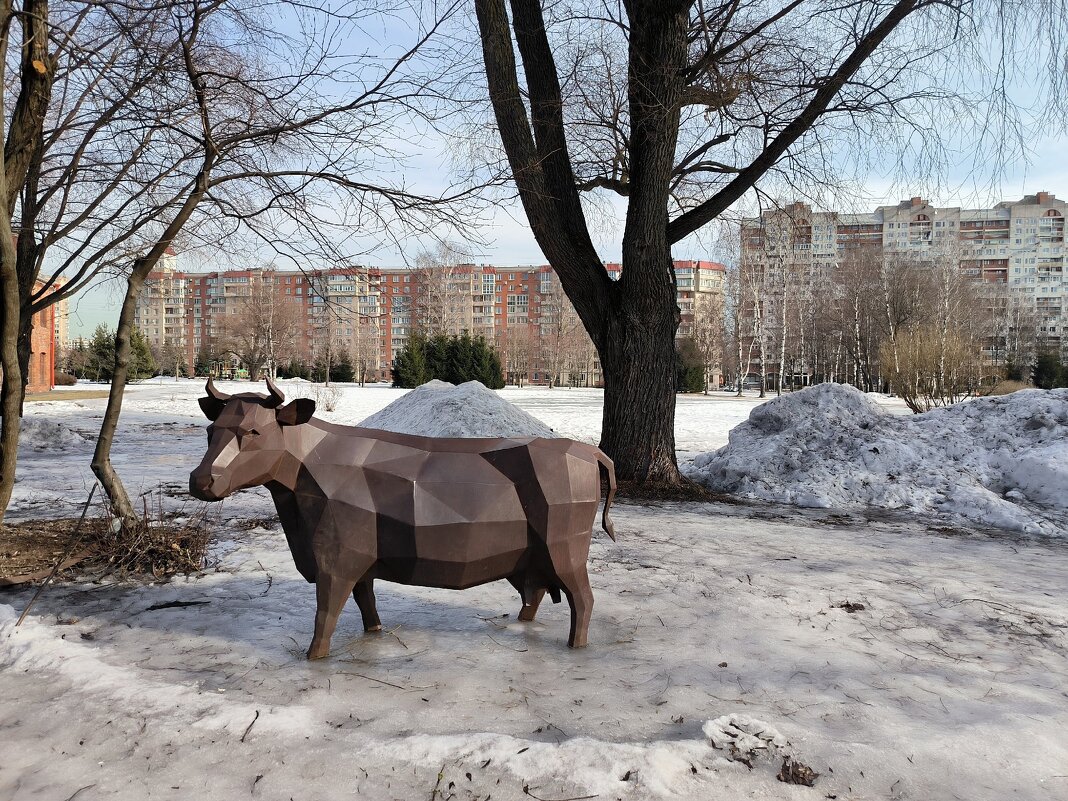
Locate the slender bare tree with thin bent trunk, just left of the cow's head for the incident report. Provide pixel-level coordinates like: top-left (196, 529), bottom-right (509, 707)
top-left (77, 0), bottom-right (472, 534)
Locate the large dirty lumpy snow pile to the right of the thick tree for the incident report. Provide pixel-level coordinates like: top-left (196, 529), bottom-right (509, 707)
top-left (691, 383), bottom-right (1068, 534)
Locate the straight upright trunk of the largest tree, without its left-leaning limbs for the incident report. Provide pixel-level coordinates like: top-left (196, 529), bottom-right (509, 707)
top-left (595, 2), bottom-right (689, 484)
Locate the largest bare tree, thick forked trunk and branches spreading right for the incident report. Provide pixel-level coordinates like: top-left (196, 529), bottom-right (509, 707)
top-left (475, 0), bottom-right (1068, 483)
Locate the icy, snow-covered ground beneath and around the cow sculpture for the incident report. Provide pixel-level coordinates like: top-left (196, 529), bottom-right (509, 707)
top-left (0, 381), bottom-right (1068, 801)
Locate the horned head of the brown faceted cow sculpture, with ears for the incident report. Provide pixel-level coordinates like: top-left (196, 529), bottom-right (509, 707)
top-left (189, 378), bottom-right (315, 501)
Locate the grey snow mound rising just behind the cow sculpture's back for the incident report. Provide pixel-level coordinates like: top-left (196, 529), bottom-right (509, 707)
top-left (360, 380), bottom-right (556, 437)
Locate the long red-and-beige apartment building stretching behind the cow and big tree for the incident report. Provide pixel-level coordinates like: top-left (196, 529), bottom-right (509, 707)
top-left (136, 254), bottom-right (725, 383)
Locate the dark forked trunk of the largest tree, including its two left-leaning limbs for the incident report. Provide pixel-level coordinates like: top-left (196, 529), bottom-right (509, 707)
top-left (475, 0), bottom-right (689, 483)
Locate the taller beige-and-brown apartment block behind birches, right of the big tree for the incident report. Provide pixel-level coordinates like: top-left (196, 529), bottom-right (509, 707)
top-left (741, 192), bottom-right (1068, 384)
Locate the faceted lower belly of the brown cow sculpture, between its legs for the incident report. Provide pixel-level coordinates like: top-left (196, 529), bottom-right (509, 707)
top-left (375, 518), bottom-right (531, 590)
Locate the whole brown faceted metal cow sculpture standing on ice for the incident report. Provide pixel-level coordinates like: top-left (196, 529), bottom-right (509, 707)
top-left (189, 379), bottom-right (615, 659)
